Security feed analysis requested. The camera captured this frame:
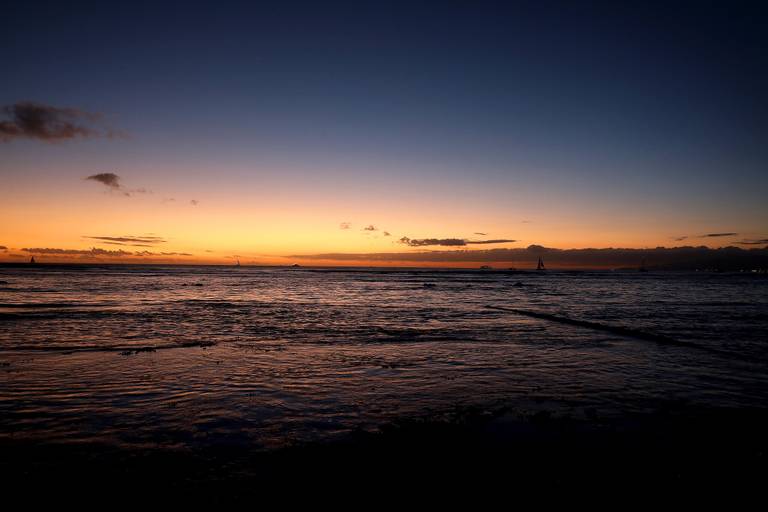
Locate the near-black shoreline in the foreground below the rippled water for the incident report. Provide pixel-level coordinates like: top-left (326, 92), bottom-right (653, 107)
top-left (0, 408), bottom-right (768, 503)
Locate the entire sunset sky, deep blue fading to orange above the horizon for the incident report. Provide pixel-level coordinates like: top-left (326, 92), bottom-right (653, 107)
top-left (0, 1), bottom-right (768, 266)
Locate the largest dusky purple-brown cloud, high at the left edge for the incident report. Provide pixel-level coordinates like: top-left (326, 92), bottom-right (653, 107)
top-left (0, 101), bottom-right (119, 142)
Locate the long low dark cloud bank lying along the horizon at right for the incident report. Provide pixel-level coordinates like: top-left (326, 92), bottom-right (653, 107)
top-left (289, 245), bottom-right (768, 270)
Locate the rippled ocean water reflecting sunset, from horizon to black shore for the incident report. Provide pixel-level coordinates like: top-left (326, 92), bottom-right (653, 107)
top-left (0, 266), bottom-right (768, 449)
